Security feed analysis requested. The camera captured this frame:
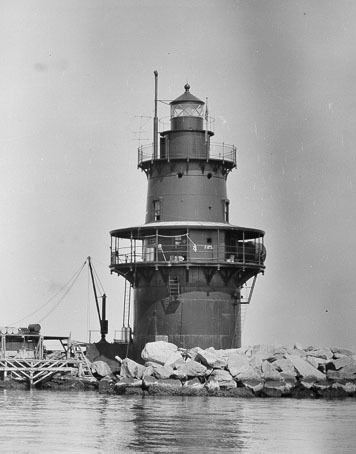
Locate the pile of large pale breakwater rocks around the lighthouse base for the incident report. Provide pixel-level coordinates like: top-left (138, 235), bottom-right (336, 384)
top-left (99, 341), bottom-right (356, 398)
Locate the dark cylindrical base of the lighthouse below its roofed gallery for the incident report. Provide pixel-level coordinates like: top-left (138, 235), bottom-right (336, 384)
top-left (134, 286), bottom-right (241, 355)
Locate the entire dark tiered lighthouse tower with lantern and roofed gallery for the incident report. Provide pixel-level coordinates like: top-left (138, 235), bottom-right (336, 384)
top-left (110, 71), bottom-right (266, 352)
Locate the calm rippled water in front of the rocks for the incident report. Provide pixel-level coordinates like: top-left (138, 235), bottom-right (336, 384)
top-left (0, 390), bottom-right (356, 454)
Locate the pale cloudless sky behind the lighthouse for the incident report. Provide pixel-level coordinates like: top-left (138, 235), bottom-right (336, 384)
top-left (0, 0), bottom-right (356, 348)
